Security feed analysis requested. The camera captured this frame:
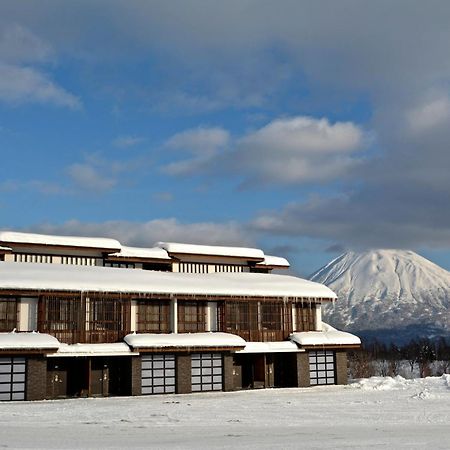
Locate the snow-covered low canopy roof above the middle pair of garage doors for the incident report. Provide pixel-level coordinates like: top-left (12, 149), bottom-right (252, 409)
top-left (124, 332), bottom-right (245, 349)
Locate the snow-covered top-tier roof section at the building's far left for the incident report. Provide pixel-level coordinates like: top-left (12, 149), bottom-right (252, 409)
top-left (0, 231), bottom-right (121, 250)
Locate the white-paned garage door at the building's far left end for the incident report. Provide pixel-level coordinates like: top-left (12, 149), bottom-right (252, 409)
top-left (0, 358), bottom-right (26, 400)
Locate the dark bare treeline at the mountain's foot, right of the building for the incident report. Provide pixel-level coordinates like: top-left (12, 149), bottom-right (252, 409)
top-left (349, 338), bottom-right (450, 378)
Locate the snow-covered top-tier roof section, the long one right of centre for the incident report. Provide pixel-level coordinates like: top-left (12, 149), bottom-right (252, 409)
top-left (156, 242), bottom-right (264, 260)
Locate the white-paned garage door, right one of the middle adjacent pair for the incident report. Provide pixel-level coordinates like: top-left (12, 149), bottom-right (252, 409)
top-left (191, 353), bottom-right (222, 392)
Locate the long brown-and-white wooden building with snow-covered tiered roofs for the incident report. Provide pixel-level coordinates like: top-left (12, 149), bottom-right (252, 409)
top-left (0, 231), bottom-right (360, 400)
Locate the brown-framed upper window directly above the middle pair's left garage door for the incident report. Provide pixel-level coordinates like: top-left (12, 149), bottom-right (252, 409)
top-left (137, 300), bottom-right (171, 333)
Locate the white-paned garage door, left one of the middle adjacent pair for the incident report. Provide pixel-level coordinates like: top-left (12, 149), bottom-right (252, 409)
top-left (141, 355), bottom-right (175, 395)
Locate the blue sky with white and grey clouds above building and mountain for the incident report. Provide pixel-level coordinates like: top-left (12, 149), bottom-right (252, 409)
top-left (0, 0), bottom-right (450, 276)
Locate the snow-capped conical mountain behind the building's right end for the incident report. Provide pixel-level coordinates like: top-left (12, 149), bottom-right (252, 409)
top-left (310, 250), bottom-right (450, 342)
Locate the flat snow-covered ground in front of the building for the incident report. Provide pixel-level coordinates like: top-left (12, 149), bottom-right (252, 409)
top-left (0, 375), bottom-right (450, 449)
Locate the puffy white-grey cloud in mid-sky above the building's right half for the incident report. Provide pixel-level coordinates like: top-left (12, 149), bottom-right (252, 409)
top-left (164, 116), bottom-right (367, 184)
